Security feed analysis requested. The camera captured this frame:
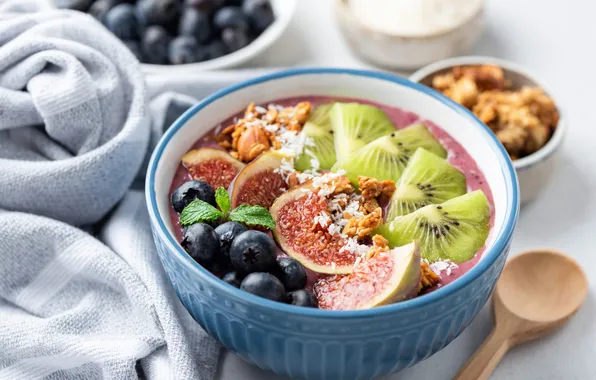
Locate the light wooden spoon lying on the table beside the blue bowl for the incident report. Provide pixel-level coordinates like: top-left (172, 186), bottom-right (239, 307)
top-left (455, 250), bottom-right (588, 380)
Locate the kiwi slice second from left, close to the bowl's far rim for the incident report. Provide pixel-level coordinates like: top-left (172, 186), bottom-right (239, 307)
top-left (329, 103), bottom-right (395, 161)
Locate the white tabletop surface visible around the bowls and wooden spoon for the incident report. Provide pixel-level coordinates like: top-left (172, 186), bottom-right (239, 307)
top-left (220, 0), bottom-right (596, 380)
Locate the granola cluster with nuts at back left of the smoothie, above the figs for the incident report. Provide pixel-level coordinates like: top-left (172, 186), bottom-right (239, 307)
top-left (216, 102), bottom-right (311, 162)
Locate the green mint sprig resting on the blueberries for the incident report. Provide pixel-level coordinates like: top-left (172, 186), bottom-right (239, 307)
top-left (180, 187), bottom-right (275, 229)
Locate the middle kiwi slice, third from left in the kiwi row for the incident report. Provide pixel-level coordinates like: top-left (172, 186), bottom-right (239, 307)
top-left (332, 123), bottom-right (447, 185)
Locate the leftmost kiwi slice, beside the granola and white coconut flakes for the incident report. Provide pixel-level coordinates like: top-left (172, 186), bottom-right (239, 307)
top-left (294, 103), bottom-right (336, 171)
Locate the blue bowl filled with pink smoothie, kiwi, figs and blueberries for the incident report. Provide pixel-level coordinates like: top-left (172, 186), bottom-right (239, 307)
top-left (146, 69), bottom-right (519, 379)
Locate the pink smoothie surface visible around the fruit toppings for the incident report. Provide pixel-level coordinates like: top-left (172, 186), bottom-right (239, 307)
top-left (170, 96), bottom-right (494, 291)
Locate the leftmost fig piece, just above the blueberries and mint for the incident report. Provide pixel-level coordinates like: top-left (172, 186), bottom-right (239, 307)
top-left (182, 148), bottom-right (244, 189)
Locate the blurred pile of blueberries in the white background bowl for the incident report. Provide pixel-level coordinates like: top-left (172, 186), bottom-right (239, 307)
top-left (56, 0), bottom-right (274, 65)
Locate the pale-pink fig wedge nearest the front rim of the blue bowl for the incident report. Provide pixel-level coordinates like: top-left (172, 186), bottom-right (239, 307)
top-left (313, 242), bottom-right (421, 310)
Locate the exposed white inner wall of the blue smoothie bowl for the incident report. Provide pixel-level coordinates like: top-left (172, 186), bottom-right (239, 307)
top-left (155, 73), bottom-right (515, 262)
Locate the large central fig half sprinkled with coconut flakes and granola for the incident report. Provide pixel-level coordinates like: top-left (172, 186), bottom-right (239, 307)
top-left (270, 177), bottom-right (380, 274)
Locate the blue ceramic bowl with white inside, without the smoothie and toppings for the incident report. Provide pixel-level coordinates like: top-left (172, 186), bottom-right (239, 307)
top-left (146, 68), bottom-right (519, 380)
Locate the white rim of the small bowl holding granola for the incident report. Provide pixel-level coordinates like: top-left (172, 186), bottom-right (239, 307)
top-left (409, 56), bottom-right (567, 172)
